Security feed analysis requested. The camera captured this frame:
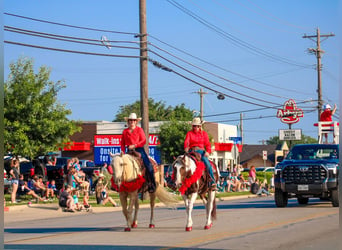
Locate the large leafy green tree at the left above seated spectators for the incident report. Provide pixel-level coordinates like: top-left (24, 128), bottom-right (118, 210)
top-left (4, 58), bottom-right (81, 158)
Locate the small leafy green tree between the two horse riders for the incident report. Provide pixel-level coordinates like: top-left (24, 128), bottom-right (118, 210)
top-left (159, 120), bottom-right (191, 163)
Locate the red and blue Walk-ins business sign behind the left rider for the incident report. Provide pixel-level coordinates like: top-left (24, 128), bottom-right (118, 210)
top-left (94, 134), bottom-right (161, 165)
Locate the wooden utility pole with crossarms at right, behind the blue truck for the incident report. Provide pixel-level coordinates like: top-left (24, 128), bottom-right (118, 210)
top-left (303, 28), bottom-right (335, 121)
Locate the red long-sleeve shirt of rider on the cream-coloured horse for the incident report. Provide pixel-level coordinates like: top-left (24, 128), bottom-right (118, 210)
top-left (121, 126), bottom-right (146, 152)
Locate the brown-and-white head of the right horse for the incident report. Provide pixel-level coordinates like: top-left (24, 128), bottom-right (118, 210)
top-left (172, 155), bottom-right (196, 188)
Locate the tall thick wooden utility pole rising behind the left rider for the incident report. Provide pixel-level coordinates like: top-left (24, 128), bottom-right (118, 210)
top-left (139, 0), bottom-right (149, 150)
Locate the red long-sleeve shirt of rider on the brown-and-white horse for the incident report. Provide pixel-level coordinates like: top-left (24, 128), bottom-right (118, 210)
top-left (184, 130), bottom-right (211, 154)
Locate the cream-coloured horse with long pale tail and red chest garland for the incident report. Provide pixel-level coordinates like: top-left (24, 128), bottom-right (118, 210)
top-left (110, 153), bottom-right (178, 232)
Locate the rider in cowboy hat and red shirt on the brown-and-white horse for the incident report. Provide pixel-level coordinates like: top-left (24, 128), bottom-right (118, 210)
top-left (184, 117), bottom-right (216, 189)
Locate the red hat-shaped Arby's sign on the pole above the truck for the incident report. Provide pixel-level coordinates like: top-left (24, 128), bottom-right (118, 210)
top-left (277, 99), bottom-right (304, 124)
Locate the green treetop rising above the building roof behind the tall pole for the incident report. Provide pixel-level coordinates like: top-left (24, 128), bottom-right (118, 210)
top-left (113, 98), bottom-right (193, 122)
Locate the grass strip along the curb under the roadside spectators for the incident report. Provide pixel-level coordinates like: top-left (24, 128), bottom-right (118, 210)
top-left (4, 190), bottom-right (256, 207)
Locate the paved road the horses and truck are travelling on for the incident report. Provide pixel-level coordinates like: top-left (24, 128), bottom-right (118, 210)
top-left (4, 197), bottom-right (339, 250)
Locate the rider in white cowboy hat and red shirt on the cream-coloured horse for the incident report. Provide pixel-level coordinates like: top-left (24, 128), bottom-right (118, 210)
top-left (121, 113), bottom-right (156, 193)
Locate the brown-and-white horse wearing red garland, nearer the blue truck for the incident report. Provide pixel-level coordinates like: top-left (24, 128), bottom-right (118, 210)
top-left (172, 154), bottom-right (219, 232)
